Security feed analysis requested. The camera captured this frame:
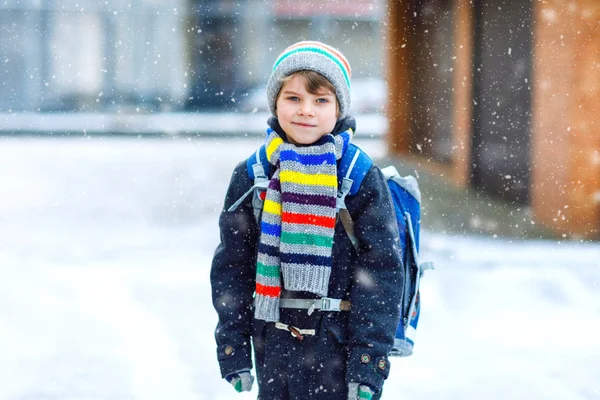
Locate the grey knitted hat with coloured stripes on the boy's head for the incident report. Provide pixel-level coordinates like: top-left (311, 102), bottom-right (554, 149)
top-left (267, 41), bottom-right (352, 118)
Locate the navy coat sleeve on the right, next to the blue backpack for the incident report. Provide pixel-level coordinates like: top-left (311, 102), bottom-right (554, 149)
top-left (346, 166), bottom-right (404, 391)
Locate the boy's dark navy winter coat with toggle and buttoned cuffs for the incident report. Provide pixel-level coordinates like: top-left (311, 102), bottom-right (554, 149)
top-left (211, 118), bottom-right (404, 400)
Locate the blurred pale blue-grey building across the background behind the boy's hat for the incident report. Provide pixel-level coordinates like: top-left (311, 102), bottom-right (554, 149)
top-left (0, 0), bottom-right (385, 112)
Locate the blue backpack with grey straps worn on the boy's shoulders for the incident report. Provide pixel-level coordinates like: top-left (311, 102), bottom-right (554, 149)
top-left (228, 143), bottom-right (433, 357)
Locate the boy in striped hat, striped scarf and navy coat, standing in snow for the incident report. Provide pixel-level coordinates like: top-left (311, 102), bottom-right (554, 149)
top-left (211, 42), bottom-right (404, 400)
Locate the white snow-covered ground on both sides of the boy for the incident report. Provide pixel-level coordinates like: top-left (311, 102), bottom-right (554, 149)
top-left (0, 137), bottom-right (600, 400)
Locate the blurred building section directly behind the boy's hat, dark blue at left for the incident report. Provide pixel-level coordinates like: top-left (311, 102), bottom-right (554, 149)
top-left (188, 0), bottom-right (385, 108)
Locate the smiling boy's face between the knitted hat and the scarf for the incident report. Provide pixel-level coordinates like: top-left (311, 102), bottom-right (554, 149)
top-left (276, 75), bottom-right (338, 144)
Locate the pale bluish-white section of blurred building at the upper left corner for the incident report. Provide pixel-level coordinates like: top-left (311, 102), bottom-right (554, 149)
top-left (0, 0), bottom-right (187, 111)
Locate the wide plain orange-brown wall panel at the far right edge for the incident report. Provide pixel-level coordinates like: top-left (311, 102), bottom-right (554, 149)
top-left (532, 0), bottom-right (600, 238)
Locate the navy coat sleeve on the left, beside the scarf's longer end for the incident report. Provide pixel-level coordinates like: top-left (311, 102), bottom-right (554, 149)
top-left (210, 163), bottom-right (258, 377)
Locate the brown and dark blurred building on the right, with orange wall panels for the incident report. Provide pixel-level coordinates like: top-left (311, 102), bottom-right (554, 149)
top-left (387, 0), bottom-right (600, 238)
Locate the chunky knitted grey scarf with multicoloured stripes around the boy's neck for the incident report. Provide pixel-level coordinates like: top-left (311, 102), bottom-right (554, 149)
top-left (254, 129), bottom-right (353, 322)
